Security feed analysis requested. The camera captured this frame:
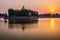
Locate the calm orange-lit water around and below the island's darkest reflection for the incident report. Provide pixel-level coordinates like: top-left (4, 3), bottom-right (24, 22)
top-left (0, 18), bottom-right (60, 40)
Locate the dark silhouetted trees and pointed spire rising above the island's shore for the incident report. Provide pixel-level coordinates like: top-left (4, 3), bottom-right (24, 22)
top-left (8, 6), bottom-right (38, 16)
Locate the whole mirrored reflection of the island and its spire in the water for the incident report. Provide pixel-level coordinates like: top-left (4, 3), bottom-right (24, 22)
top-left (8, 20), bottom-right (38, 31)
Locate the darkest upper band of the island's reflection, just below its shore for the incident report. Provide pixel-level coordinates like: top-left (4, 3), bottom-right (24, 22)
top-left (9, 19), bottom-right (38, 24)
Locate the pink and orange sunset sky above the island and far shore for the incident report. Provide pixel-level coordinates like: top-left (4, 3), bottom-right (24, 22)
top-left (0, 0), bottom-right (60, 13)
